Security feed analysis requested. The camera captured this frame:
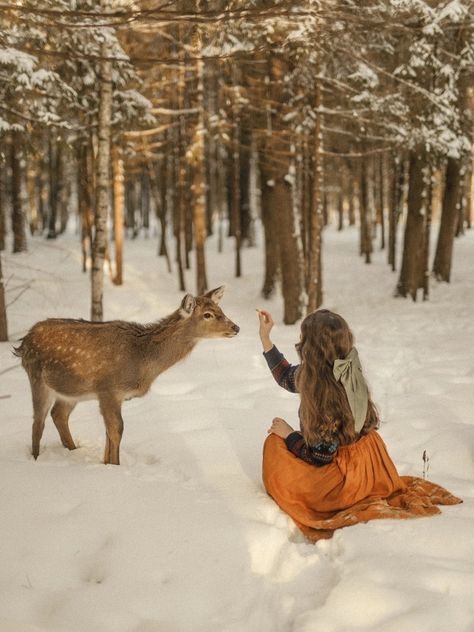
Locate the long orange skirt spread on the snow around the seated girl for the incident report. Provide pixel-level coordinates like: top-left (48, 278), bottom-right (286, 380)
top-left (263, 431), bottom-right (462, 541)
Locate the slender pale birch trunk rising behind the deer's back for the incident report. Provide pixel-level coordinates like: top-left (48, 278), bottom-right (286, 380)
top-left (91, 41), bottom-right (112, 321)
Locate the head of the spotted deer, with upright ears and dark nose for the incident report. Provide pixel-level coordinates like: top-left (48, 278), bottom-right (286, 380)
top-left (180, 285), bottom-right (240, 338)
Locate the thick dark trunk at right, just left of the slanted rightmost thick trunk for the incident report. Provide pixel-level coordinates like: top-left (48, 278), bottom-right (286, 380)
top-left (396, 151), bottom-right (426, 301)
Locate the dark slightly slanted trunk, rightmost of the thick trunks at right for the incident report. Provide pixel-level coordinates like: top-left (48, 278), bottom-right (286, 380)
top-left (433, 158), bottom-right (461, 283)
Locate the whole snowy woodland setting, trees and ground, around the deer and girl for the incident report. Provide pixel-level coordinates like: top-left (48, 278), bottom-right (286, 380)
top-left (0, 0), bottom-right (474, 632)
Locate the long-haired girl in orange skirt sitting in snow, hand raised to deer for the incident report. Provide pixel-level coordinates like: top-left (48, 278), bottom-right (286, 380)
top-left (258, 309), bottom-right (462, 540)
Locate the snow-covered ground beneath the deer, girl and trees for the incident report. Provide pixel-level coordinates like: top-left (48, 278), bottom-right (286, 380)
top-left (0, 228), bottom-right (474, 632)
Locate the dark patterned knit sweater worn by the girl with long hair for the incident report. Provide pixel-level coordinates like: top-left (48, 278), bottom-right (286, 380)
top-left (263, 345), bottom-right (338, 467)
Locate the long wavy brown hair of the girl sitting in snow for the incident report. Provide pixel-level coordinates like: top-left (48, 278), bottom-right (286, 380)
top-left (296, 309), bottom-right (379, 445)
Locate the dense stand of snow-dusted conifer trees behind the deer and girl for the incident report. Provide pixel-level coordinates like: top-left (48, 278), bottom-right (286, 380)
top-left (0, 0), bottom-right (474, 340)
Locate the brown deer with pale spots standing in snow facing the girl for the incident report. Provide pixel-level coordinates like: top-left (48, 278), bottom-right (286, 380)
top-left (13, 286), bottom-right (240, 465)
